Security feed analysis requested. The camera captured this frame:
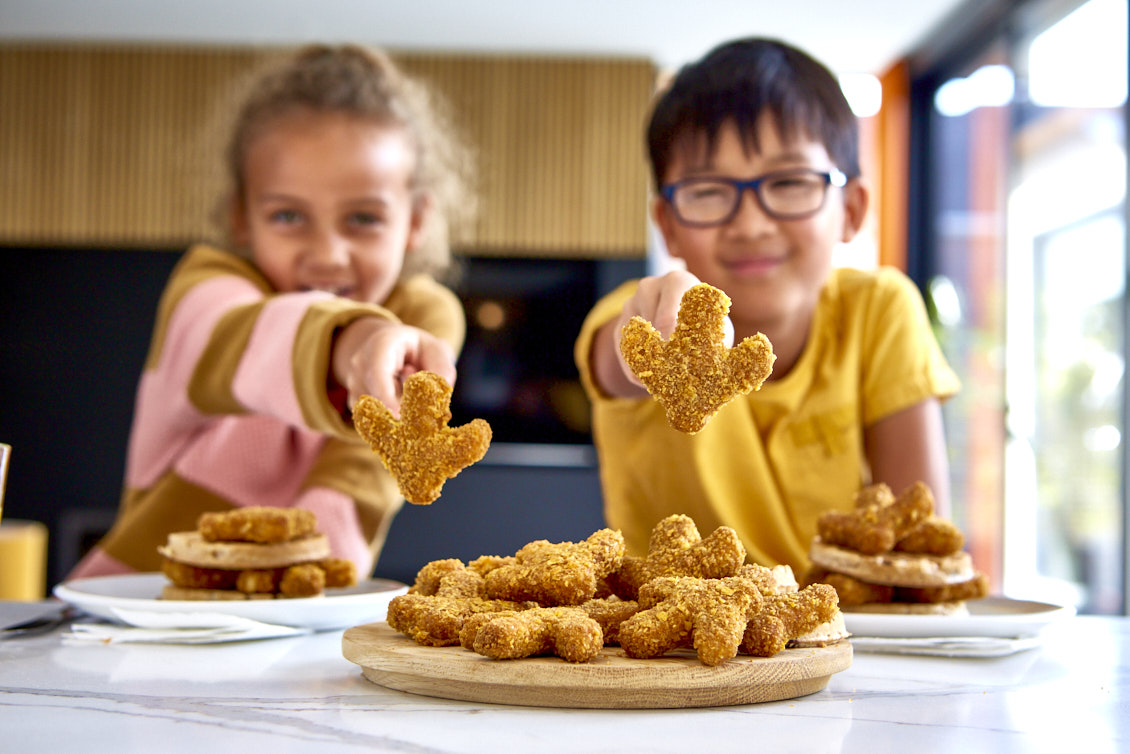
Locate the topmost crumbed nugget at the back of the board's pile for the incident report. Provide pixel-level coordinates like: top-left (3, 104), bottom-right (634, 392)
top-left (608, 514), bottom-right (746, 599)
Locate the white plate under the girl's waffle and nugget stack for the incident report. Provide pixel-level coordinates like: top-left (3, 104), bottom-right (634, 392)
top-left (54, 573), bottom-right (408, 631)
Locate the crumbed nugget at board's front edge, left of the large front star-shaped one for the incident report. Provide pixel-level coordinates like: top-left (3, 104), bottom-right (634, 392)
top-left (460, 607), bottom-right (605, 662)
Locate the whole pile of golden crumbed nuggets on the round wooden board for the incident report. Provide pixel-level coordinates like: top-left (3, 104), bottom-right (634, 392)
top-left (388, 515), bottom-right (846, 666)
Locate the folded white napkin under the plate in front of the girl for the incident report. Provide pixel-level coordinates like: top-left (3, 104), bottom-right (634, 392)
top-left (63, 607), bottom-right (312, 644)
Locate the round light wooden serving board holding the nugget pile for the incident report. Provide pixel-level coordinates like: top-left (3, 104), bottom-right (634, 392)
top-left (341, 623), bottom-right (852, 709)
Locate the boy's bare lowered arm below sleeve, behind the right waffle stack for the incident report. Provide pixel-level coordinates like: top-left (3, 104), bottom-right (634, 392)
top-left (863, 398), bottom-right (950, 518)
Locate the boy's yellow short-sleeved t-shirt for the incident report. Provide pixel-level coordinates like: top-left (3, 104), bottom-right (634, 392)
top-left (575, 268), bottom-right (959, 573)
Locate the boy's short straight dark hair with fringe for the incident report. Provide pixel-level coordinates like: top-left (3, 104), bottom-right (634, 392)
top-left (647, 37), bottom-right (860, 188)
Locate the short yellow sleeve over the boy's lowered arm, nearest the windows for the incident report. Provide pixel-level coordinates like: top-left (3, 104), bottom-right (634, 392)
top-left (861, 268), bottom-right (961, 425)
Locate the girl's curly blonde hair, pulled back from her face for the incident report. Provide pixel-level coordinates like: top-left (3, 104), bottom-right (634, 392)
top-left (215, 45), bottom-right (476, 282)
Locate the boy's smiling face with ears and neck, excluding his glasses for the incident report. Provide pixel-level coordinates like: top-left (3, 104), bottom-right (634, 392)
top-left (654, 118), bottom-right (867, 366)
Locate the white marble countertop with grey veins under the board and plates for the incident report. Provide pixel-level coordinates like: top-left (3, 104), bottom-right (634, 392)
top-left (0, 616), bottom-right (1130, 754)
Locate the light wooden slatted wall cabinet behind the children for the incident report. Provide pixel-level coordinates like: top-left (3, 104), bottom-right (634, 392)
top-left (0, 45), bottom-right (655, 258)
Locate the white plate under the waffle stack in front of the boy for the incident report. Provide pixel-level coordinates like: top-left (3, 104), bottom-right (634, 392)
top-left (844, 597), bottom-right (1075, 639)
